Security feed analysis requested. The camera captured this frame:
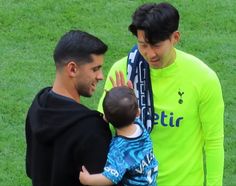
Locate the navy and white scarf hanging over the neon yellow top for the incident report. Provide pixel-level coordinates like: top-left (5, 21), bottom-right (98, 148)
top-left (127, 45), bottom-right (154, 133)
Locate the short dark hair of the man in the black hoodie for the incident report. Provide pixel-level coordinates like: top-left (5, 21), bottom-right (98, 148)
top-left (53, 30), bottom-right (108, 67)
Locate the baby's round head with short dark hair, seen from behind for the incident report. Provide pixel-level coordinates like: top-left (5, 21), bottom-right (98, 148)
top-left (103, 86), bottom-right (138, 129)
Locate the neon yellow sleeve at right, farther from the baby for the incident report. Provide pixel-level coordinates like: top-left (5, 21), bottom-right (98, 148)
top-left (199, 73), bottom-right (224, 186)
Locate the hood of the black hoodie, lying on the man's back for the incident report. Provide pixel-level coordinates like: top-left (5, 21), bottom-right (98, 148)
top-left (26, 87), bottom-right (102, 142)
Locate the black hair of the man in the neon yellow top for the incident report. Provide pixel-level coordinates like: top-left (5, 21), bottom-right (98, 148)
top-left (129, 3), bottom-right (179, 45)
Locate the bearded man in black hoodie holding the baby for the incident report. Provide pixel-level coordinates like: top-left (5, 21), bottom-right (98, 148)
top-left (25, 30), bottom-right (111, 186)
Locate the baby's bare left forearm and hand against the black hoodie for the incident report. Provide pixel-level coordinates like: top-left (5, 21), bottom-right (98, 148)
top-left (79, 166), bottom-right (113, 186)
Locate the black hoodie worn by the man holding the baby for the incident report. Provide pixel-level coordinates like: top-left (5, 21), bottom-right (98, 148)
top-left (25, 87), bottom-right (111, 186)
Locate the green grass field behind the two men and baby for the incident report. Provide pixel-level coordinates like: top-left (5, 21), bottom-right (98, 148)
top-left (0, 0), bottom-right (236, 186)
